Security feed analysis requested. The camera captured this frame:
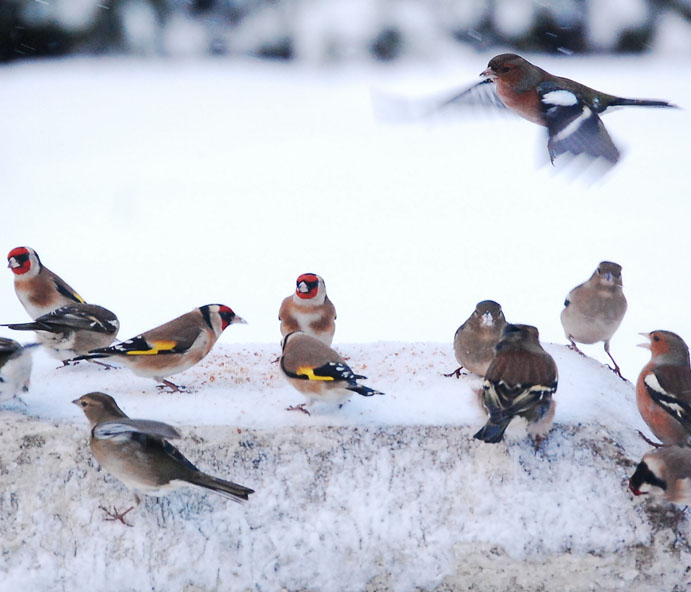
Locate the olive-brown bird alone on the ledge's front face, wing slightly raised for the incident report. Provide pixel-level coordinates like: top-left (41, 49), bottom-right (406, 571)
top-left (72, 393), bottom-right (254, 524)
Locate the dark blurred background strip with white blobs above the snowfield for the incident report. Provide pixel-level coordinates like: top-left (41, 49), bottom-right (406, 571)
top-left (0, 0), bottom-right (691, 63)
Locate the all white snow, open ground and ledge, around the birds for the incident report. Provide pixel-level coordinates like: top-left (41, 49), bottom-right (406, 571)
top-left (0, 50), bottom-right (691, 590)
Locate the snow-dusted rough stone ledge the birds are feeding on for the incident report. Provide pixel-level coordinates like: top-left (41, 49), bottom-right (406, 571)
top-left (0, 343), bottom-right (691, 591)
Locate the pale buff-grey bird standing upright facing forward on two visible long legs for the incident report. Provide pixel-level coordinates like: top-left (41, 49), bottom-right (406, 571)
top-left (561, 261), bottom-right (627, 379)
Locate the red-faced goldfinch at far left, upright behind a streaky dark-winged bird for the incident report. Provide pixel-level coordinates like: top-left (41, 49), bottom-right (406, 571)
top-left (7, 247), bottom-right (84, 320)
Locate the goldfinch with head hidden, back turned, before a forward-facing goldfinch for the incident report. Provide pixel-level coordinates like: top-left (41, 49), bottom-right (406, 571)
top-left (280, 331), bottom-right (384, 415)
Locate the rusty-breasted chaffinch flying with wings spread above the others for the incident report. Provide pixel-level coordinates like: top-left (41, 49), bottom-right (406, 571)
top-left (442, 53), bottom-right (676, 164)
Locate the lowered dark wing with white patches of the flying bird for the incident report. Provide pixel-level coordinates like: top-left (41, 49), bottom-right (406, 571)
top-left (538, 82), bottom-right (619, 164)
